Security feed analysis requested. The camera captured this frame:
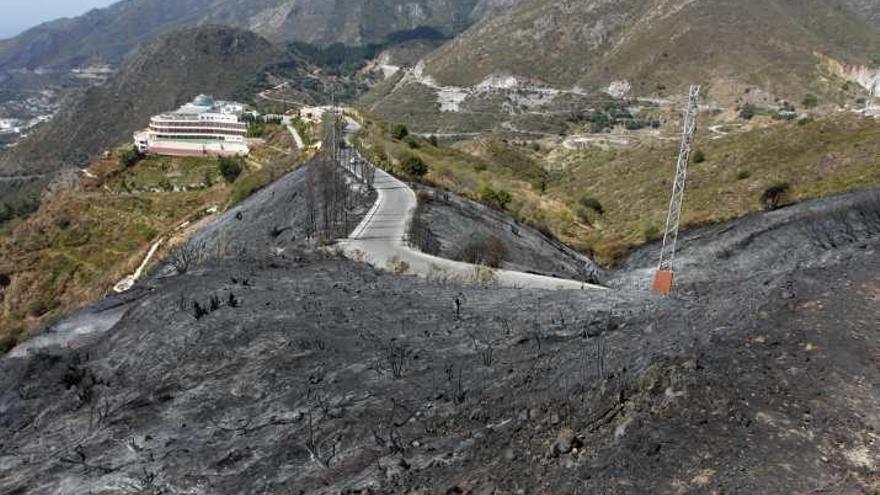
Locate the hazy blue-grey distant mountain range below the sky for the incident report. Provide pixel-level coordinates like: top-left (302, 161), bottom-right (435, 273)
top-left (0, 0), bottom-right (521, 69)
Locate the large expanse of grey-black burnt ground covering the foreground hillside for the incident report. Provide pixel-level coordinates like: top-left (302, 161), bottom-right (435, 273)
top-left (0, 157), bottom-right (880, 494)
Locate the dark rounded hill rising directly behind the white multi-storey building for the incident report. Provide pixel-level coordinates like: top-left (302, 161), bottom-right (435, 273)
top-left (0, 26), bottom-right (279, 173)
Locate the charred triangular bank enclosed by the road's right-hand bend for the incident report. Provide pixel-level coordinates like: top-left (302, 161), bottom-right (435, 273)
top-left (410, 185), bottom-right (604, 282)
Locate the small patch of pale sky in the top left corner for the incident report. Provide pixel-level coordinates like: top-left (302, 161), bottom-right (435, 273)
top-left (0, 0), bottom-right (118, 39)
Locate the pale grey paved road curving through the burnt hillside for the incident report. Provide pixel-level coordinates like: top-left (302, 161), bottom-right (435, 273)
top-left (340, 121), bottom-right (603, 289)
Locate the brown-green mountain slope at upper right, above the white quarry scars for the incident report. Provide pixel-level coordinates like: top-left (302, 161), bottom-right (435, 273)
top-left (426, 0), bottom-right (880, 95)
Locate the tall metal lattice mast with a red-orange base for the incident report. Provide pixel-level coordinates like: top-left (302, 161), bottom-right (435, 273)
top-left (654, 84), bottom-right (700, 294)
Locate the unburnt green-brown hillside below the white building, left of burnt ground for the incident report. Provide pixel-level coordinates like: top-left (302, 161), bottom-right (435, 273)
top-left (0, 127), bottom-right (299, 352)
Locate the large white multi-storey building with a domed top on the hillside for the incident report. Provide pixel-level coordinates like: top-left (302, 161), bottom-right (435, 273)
top-left (134, 95), bottom-right (250, 156)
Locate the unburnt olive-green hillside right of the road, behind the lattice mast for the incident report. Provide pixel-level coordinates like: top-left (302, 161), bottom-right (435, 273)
top-left (362, 115), bottom-right (880, 265)
